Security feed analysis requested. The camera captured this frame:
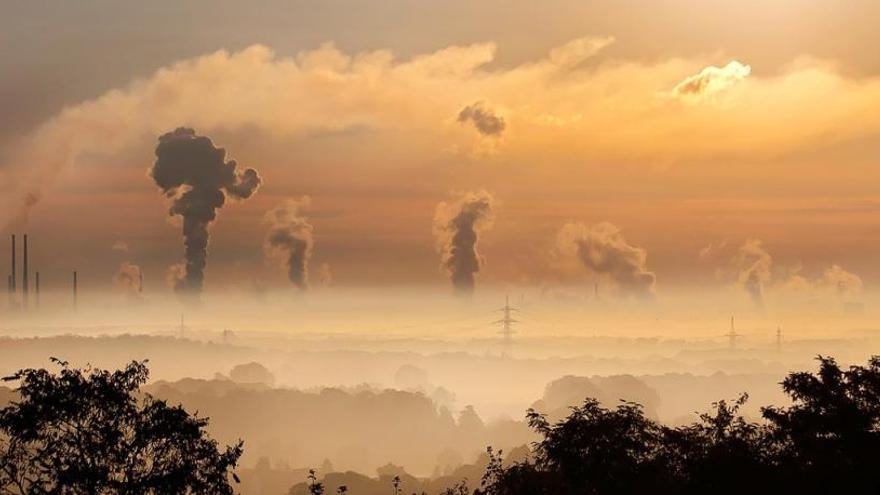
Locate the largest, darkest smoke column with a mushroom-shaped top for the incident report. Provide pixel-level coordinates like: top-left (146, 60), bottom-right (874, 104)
top-left (150, 127), bottom-right (261, 293)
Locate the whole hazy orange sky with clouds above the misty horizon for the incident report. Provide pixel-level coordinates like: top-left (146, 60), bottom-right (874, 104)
top-left (0, 0), bottom-right (880, 299)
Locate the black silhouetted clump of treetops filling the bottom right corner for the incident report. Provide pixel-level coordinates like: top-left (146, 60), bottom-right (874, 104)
top-left (476, 357), bottom-right (880, 495)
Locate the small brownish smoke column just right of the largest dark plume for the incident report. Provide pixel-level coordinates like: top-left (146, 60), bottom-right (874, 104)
top-left (264, 196), bottom-right (314, 290)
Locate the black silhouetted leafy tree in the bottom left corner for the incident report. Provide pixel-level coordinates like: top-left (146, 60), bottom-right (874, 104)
top-left (0, 358), bottom-right (243, 495)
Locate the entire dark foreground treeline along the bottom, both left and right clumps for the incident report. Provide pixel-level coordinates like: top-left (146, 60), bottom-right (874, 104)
top-left (0, 357), bottom-right (880, 495)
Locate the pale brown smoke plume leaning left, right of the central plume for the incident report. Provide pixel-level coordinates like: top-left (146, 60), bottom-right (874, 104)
top-left (557, 222), bottom-right (656, 299)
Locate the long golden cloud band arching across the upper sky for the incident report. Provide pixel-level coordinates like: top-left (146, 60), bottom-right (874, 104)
top-left (0, 37), bottom-right (880, 231)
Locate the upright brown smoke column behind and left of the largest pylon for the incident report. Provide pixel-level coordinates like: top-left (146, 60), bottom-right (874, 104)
top-left (434, 191), bottom-right (495, 294)
